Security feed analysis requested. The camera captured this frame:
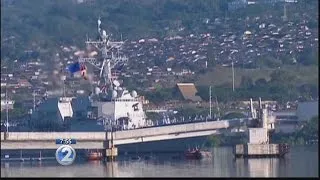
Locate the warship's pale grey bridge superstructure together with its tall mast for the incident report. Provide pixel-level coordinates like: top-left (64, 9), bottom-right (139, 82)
top-left (79, 18), bottom-right (146, 129)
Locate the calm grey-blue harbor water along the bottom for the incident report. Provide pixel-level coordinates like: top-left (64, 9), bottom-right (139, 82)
top-left (1, 145), bottom-right (319, 177)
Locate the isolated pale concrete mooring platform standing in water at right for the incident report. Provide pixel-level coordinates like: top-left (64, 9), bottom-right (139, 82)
top-left (234, 98), bottom-right (289, 158)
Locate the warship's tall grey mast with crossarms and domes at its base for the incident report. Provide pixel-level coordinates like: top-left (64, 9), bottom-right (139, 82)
top-left (79, 17), bottom-right (128, 134)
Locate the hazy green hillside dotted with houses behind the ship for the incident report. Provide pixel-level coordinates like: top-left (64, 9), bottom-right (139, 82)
top-left (1, 0), bottom-right (318, 126)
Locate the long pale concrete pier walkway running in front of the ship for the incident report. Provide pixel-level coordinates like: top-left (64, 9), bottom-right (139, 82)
top-left (1, 119), bottom-right (250, 150)
